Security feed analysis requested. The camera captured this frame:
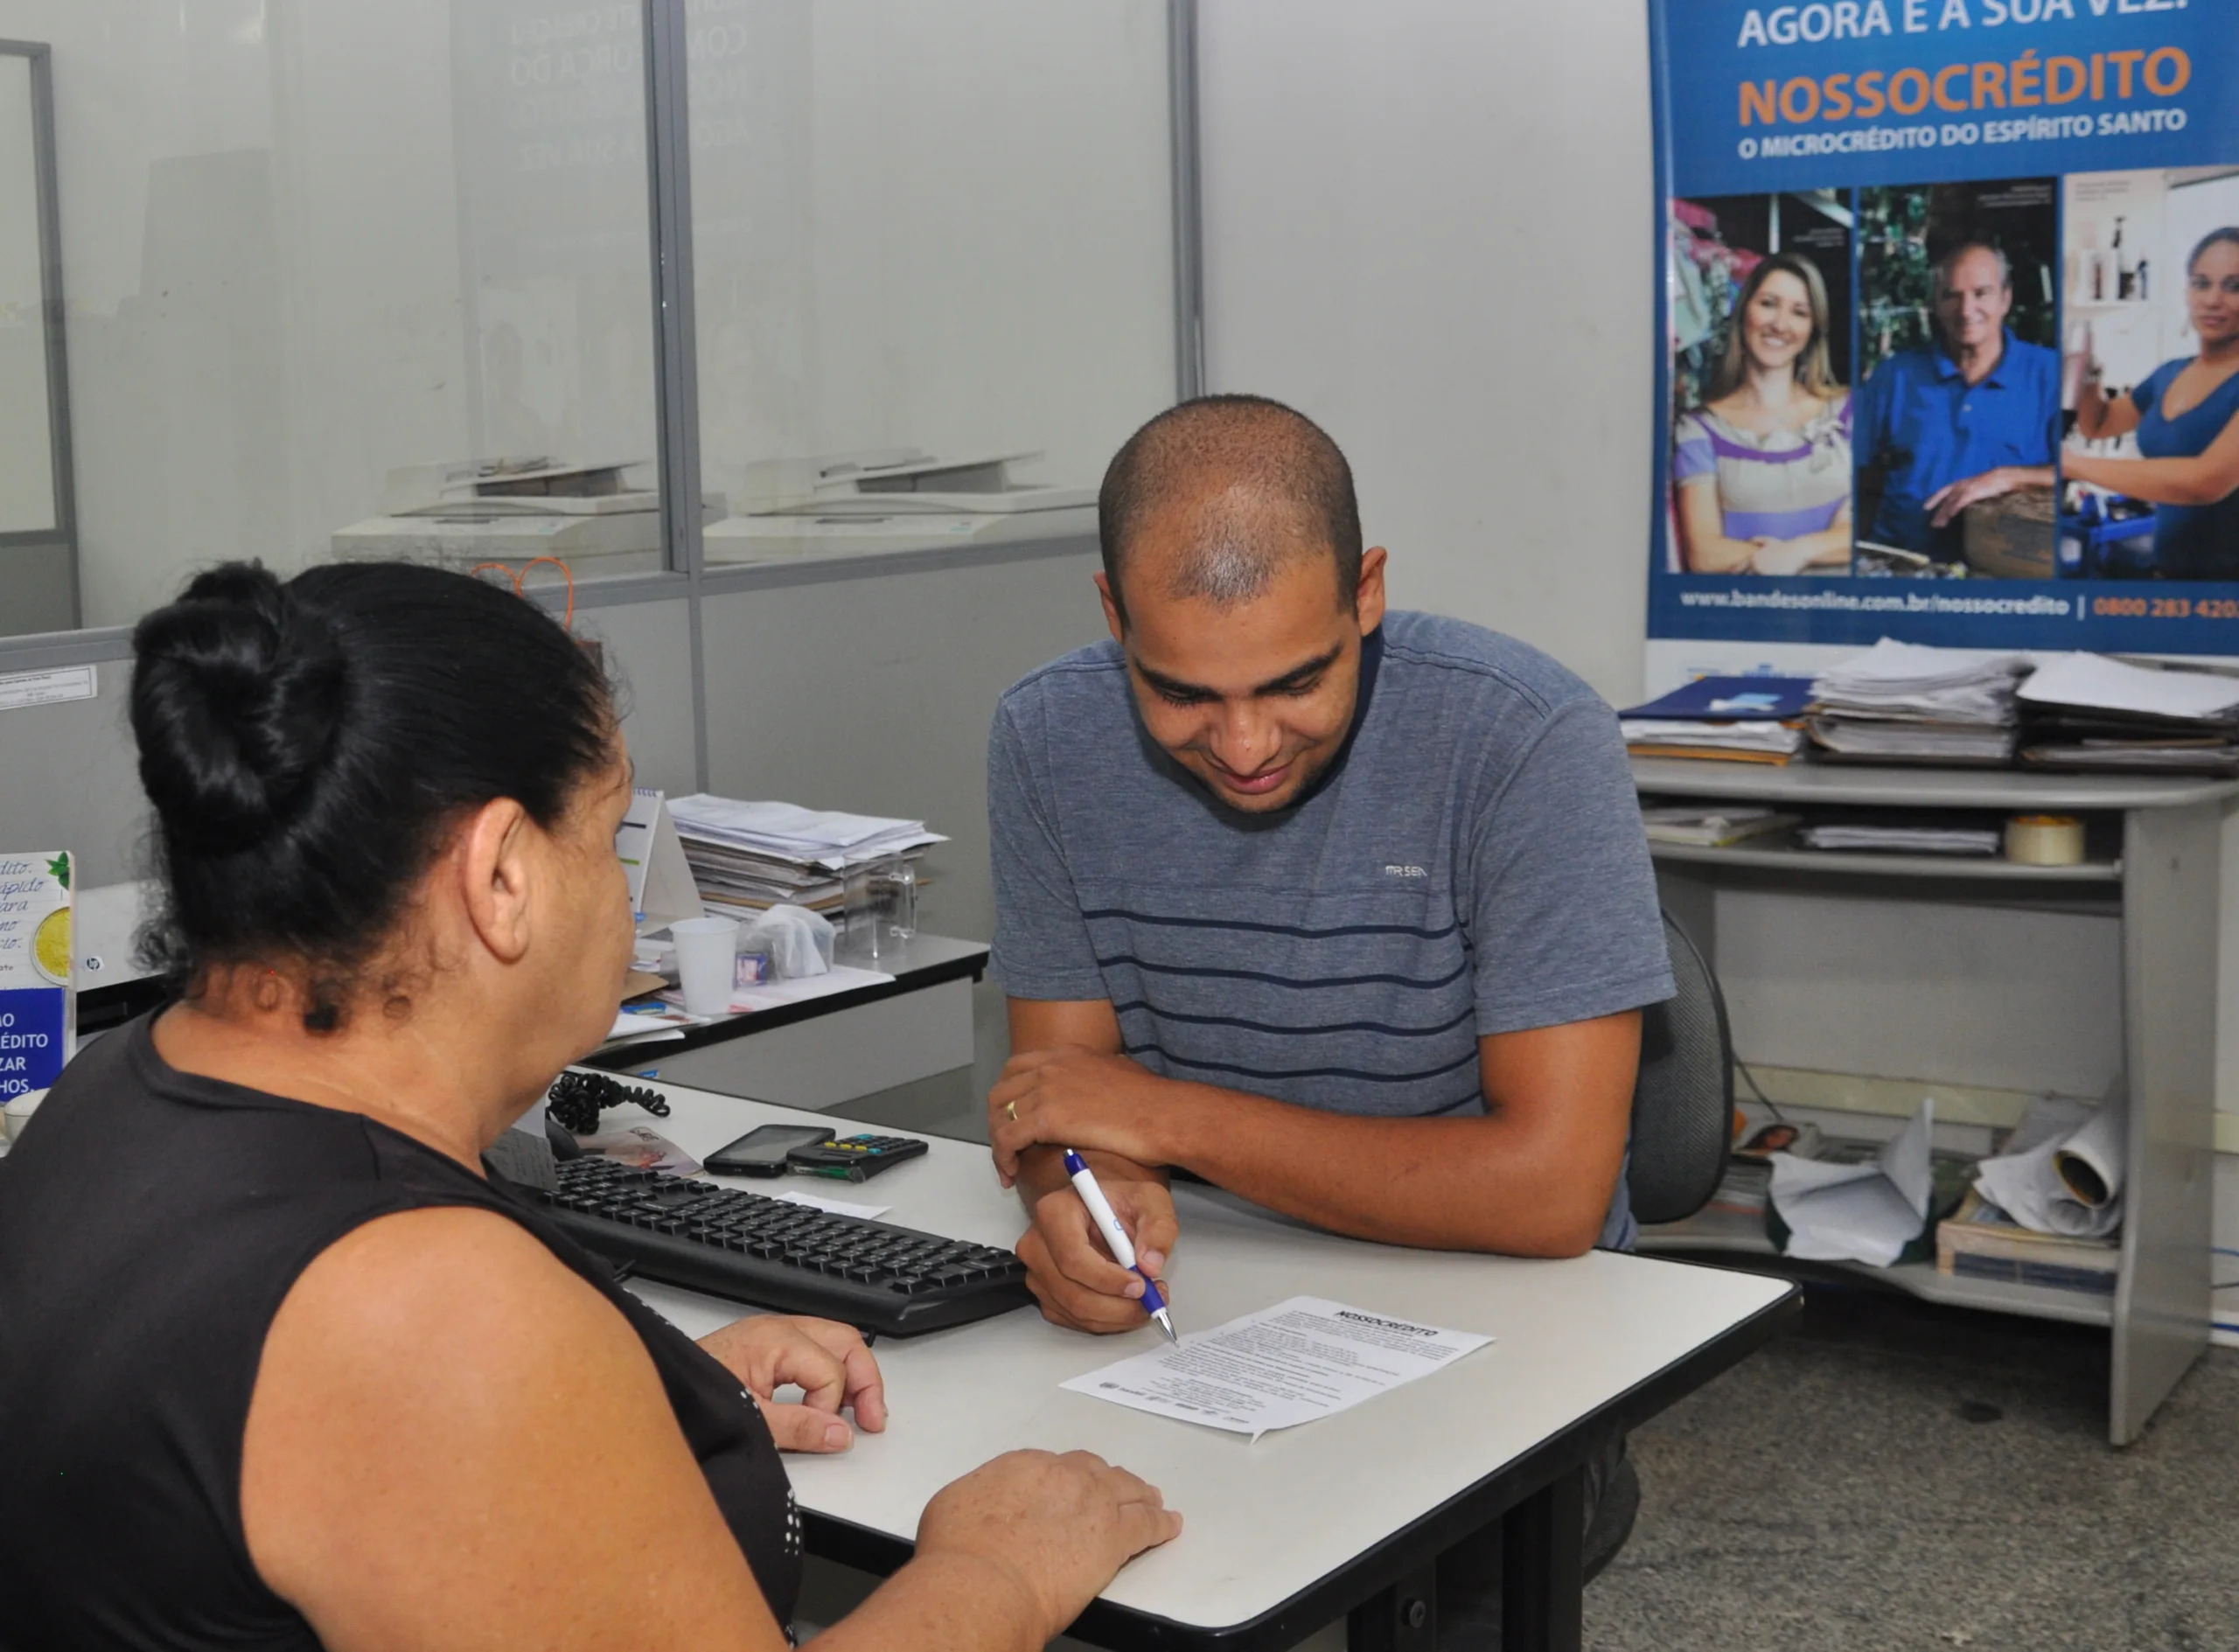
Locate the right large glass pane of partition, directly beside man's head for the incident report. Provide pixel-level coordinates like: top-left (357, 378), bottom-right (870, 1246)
top-left (689, 0), bottom-right (1175, 567)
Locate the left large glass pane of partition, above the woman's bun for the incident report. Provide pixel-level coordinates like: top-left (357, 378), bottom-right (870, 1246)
top-left (0, 0), bottom-right (660, 627)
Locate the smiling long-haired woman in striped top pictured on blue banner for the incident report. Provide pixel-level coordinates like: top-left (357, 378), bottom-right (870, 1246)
top-left (1672, 253), bottom-right (1850, 573)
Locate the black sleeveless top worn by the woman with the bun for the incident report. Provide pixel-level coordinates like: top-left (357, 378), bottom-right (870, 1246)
top-left (0, 1019), bottom-right (801, 1652)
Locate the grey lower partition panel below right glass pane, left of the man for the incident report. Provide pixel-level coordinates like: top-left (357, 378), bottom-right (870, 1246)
top-left (703, 540), bottom-right (1104, 940)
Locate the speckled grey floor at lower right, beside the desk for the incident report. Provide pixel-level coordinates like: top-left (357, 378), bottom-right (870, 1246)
top-left (1585, 1285), bottom-right (2239, 1652)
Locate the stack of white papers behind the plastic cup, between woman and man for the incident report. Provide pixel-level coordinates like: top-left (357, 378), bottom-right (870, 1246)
top-left (669, 792), bottom-right (947, 916)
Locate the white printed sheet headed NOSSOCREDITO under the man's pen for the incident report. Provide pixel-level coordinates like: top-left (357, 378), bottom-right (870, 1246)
top-left (1064, 1296), bottom-right (1494, 1439)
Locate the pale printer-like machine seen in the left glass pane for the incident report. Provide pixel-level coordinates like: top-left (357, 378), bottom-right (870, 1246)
top-left (333, 459), bottom-right (725, 573)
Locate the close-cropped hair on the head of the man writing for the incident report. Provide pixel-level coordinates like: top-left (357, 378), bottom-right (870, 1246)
top-left (1097, 396), bottom-right (1361, 623)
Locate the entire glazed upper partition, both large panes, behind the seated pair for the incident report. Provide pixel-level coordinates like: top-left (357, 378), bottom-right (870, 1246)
top-left (0, 0), bottom-right (1178, 635)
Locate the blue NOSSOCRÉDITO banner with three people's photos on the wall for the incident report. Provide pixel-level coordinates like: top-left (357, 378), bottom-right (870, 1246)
top-left (1648, 0), bottom-right (2239, 662)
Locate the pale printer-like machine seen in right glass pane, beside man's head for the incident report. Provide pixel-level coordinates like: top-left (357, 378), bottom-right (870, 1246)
top-left (708, 448), bottom-right (1097, 561)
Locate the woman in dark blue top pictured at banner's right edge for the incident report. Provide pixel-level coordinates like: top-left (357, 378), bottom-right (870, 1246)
top-left (2060, 227), bottom-right (2239, 580)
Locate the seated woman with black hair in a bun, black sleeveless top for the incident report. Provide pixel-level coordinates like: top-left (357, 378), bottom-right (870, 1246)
top-left (0, 564), bottom-right (1180, 1652)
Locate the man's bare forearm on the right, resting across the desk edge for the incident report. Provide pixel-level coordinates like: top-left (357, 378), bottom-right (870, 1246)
top-left (1154, 1081), bottom-right (1623, 1256)
